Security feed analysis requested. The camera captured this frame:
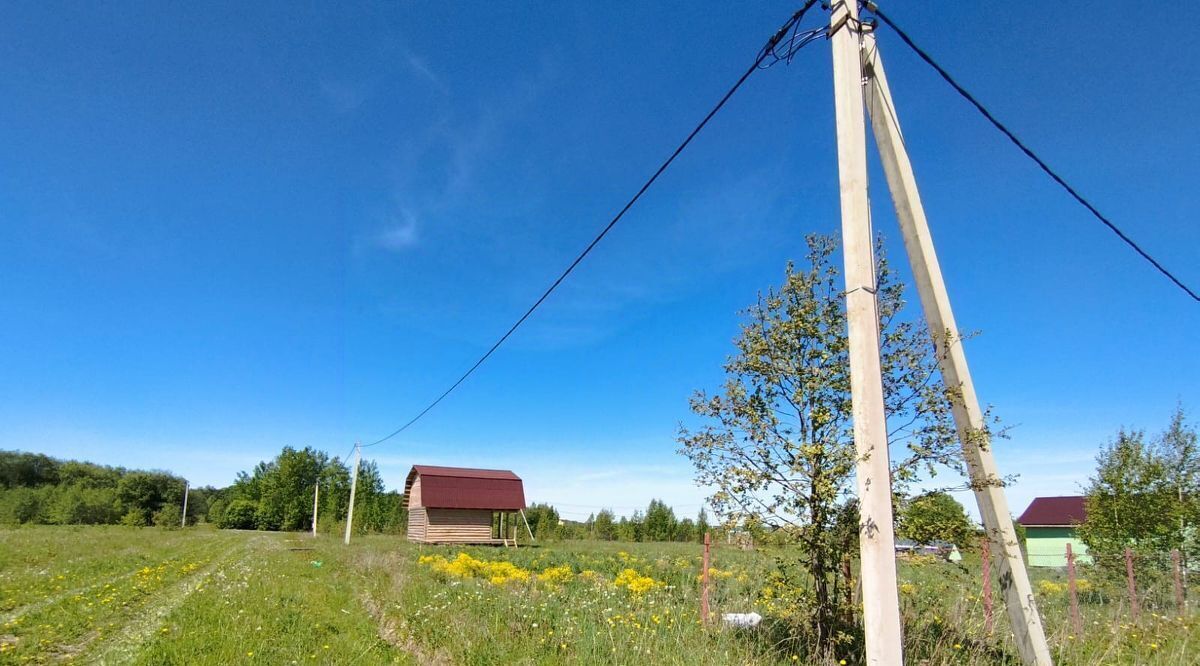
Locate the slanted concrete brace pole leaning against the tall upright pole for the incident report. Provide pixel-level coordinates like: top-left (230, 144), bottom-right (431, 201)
top-left (862, 32), bottom-right (1051, 665)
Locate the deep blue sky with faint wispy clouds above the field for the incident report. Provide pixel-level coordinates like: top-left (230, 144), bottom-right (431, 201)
top-left (0, 2), bottom-right (1200, 517)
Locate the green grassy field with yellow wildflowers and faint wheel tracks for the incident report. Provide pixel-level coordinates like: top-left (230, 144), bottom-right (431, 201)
top-left (0, 527), bottom-right (1200, 665)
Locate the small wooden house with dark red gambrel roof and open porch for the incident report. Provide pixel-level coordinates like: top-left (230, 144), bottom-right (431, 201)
top-left (404, 464), bottom-right (524, 544)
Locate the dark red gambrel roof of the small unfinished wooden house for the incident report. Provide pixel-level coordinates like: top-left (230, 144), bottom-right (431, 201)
top-left (404, 464), bottom-right (524, 511)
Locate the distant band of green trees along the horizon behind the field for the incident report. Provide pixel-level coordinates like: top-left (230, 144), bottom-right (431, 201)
top-left (0, 446), bottom-right (984, 545)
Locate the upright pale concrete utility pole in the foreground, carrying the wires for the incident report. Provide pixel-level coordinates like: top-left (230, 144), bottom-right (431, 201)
top-left (829, 0), bottom-right (904, 666)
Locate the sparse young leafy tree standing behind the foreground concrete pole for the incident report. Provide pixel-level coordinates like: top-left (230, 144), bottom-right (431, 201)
top-left (679, 235), bottom-right (961, 644)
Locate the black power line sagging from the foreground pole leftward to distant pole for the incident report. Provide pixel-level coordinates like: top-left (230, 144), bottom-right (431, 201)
top-left (364, 0), bottom-right (816, 446)
